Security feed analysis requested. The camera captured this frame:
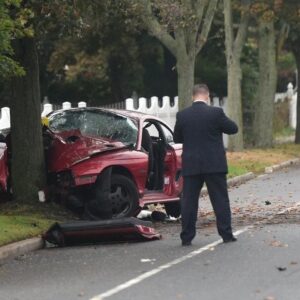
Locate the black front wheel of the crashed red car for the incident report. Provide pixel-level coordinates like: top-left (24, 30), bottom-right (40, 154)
top-left (84, 174), bottom-right (139, 220)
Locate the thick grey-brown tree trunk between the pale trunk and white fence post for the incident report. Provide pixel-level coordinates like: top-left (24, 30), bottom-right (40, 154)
top-left (253, 21), bottom-right (277, 148)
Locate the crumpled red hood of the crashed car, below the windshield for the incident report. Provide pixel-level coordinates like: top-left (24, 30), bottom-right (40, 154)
top-left (47, 130), bottom-right (127, 172)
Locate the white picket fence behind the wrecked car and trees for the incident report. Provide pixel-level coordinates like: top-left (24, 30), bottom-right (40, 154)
top-left (0, 83), bottom-right (297, 132)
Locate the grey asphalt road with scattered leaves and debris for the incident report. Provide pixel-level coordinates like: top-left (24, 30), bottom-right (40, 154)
top-left (0, 167), bottom-right (300, 300)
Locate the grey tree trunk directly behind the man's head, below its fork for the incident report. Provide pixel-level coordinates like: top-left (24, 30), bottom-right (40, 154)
top-left (176, 55), bottom-right (195, 110)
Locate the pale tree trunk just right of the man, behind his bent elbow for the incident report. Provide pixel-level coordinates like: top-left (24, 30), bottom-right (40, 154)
top-left (226, 56), bottom-right (244, 151)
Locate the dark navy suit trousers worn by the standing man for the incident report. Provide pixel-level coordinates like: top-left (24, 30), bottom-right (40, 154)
top-left (180, 173), bottom-right (232, 242)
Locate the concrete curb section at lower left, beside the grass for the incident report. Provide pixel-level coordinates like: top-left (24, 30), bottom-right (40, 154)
top-left (0, 237), bottom-right (44, 262)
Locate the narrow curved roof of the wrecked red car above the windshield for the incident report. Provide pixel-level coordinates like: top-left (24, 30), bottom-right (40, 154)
top-left (47, 107), bottom-right (162, 122)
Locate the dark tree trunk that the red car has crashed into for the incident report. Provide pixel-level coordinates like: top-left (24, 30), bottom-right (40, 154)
top-left (11, 38), bottom-right (46, 203)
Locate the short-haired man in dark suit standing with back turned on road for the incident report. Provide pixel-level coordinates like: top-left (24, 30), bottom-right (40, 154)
top-left (174, 84), bottom-right (238, 246)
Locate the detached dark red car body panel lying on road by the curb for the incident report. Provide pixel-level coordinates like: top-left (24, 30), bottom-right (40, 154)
top-left (43, 218), bottom-right (161, 247)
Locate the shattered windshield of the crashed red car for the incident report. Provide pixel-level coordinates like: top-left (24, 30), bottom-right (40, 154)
top-left (49, 110), bottom-right (138, 145)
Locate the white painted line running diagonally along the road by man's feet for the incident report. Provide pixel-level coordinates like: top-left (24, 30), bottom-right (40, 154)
top-left (90, 226), bottom-right (252, 300)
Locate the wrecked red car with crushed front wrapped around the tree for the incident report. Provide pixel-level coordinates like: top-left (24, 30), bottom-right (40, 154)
top-left (0, 108), bottom-right (182, 219)
